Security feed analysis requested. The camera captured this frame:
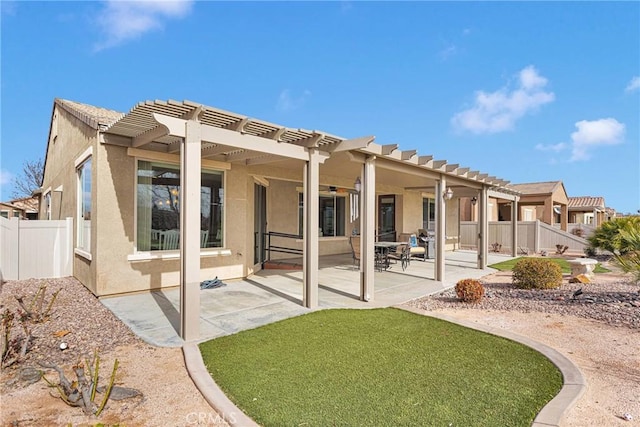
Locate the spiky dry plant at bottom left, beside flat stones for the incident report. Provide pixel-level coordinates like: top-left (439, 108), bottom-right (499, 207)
top-left (40, 351), bottom-right (118, 416)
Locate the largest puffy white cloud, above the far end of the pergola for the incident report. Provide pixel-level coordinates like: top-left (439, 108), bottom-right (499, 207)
top-left (451, 65), bottom-right (555, 134)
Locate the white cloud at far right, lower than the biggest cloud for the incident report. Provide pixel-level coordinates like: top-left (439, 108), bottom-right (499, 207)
top-left (571, 118), bottom-right (625, 161)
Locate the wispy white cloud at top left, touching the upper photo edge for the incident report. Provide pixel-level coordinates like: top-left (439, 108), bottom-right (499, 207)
top-left (96, 0), bottom-right (194, 50)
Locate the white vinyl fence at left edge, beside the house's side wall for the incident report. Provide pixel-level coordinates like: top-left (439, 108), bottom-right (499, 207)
top-left (0, 217), bottom-right (73, 280)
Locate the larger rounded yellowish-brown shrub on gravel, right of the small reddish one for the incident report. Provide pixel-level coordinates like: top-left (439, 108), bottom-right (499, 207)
top-left (511, 258), bottom-right (562, 289)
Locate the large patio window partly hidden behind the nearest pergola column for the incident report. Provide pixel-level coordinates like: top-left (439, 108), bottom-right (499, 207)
top-left (137, 160), bottom-right (224, 251)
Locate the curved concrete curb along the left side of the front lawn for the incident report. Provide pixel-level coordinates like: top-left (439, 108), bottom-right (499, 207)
top-left (182, 342), bottom-right (258, 427)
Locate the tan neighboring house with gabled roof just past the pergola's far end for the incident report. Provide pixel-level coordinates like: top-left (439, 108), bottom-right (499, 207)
top-left (498, 181), bottom-right (569, 231)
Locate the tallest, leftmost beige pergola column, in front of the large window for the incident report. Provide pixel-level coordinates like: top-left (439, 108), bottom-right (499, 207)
top-left (180, 120), bottom-right (202, 341)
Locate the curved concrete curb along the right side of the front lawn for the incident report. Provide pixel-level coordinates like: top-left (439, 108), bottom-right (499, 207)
top-left (394, 305), bottom-right (587, 427)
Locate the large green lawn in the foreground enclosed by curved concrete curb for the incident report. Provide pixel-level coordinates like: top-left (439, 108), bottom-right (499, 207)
top-left (200, 308), bottom-right (562, 426)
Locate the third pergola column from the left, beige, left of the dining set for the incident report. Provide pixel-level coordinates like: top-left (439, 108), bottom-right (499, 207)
top-left (360, 156), bottom-right (376, 301)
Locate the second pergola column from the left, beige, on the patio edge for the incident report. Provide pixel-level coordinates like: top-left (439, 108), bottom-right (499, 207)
top-left (302, 149), bottom-right (320, 308)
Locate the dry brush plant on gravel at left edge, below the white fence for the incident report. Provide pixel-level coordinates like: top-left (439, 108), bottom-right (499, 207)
top-left (0, 283), bottom-right (60, 369)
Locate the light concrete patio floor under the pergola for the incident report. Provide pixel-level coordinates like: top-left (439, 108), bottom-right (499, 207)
top-left (101, 250), bottom-right (511, 347)
